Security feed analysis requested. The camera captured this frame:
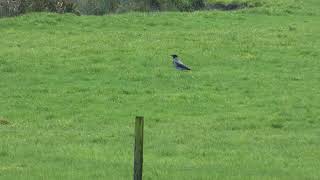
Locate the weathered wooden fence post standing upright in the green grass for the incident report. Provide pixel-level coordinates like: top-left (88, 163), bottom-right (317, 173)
top-left (133, 116), bottom-right (144, 180)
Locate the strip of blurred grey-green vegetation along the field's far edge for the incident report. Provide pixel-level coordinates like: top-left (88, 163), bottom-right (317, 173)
top-left (0, 0), bottom-right (260, 17)
